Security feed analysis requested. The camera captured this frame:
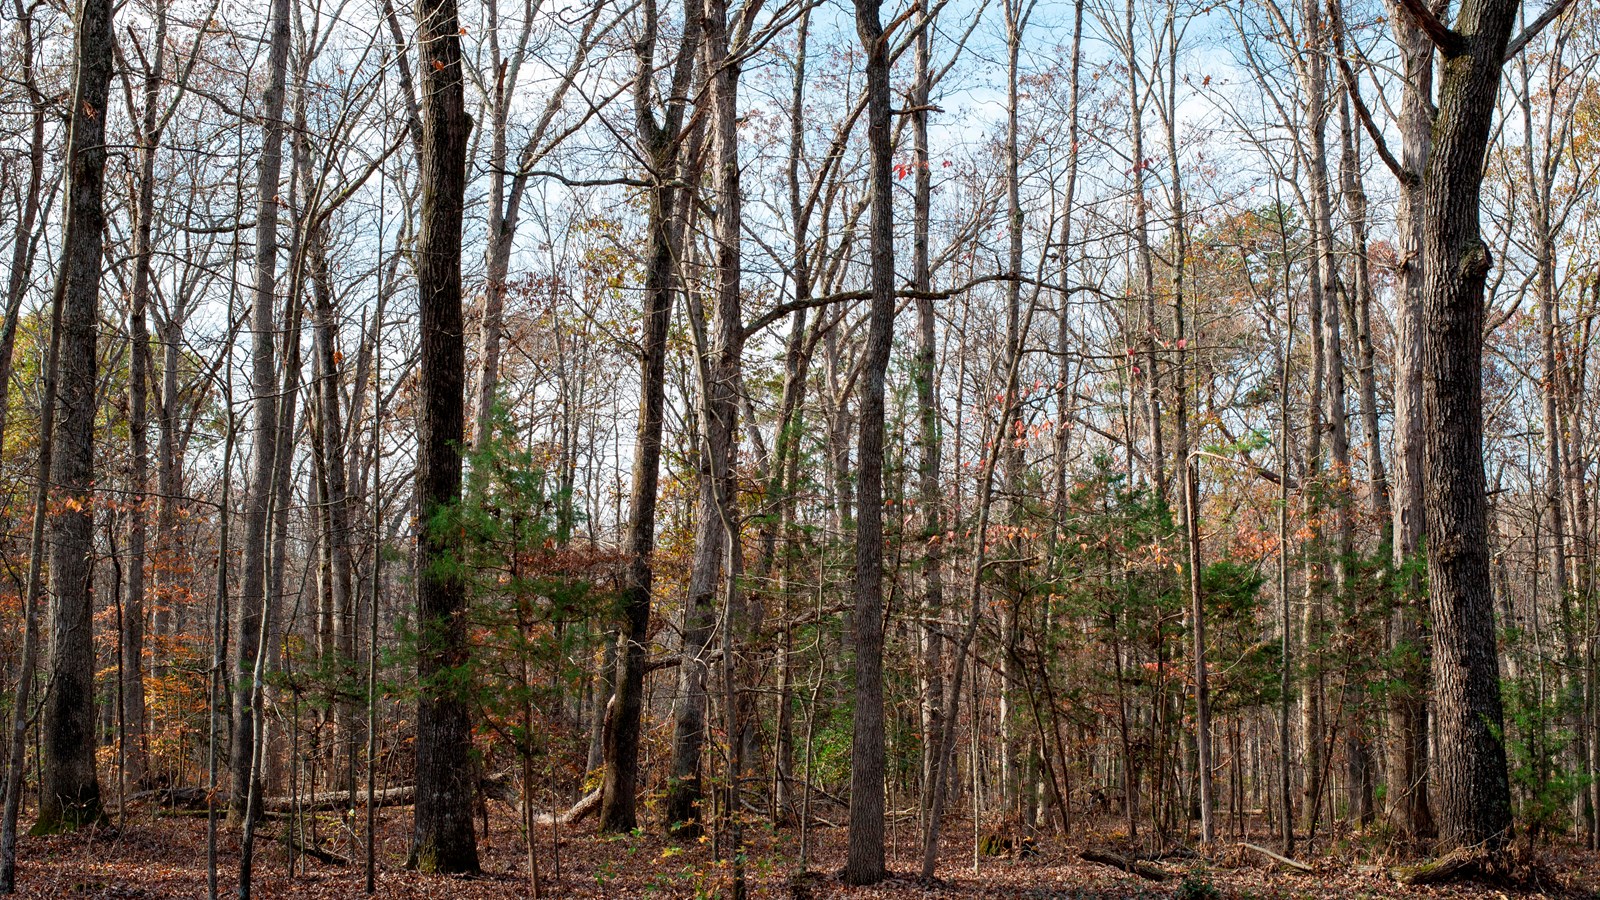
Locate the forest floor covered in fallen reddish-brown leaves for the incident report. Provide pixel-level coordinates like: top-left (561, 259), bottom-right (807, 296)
top-left (18, 794), bottom-right (1600, 900)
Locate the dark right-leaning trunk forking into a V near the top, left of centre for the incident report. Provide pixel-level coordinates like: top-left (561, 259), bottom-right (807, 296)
top-left (600, 0), bottom-right (699, 833)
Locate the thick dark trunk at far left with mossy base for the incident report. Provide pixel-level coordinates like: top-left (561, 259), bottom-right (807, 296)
top-left (34, 0), bottom-right (114, 833)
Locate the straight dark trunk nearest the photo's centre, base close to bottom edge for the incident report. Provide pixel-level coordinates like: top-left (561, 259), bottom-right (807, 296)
top-left (845, 0), bottom-right (894, 884)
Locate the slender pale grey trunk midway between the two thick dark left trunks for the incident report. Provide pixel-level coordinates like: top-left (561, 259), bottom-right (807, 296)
top-left (229, 0), bottom-right (290, 823)
